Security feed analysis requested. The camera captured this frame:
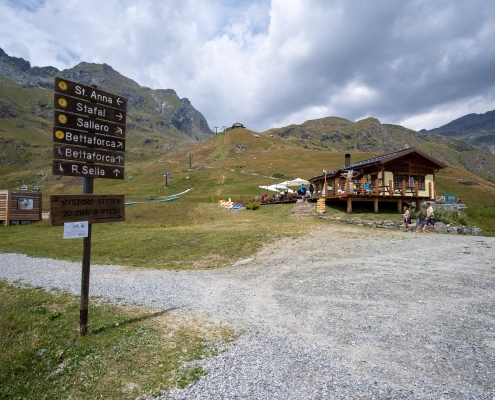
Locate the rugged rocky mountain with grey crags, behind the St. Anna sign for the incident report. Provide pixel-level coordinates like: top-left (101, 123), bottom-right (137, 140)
top-left (0, 49), bottom-right (213, 155)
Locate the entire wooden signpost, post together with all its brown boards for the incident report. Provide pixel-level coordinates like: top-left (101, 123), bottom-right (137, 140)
top-left (50, 78), bottom-right (127, 335)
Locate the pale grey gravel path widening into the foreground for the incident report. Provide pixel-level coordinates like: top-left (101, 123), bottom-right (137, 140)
top-left (0, 223), bottom-right (495, 399)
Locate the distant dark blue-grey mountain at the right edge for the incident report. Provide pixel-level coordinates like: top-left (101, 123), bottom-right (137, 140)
top-left (420, 110), bottom-right (495, 154)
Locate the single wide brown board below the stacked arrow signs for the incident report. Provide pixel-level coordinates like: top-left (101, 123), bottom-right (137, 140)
top-left (50, 194), bottom-right (125, 226)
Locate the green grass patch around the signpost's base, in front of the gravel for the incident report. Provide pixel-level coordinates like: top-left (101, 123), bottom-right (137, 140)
top-left (0, 280), bottom-right (233, 399)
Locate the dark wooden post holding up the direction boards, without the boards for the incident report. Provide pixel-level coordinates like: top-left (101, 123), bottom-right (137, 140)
top-left (79, 178), bottom-right (94, 336)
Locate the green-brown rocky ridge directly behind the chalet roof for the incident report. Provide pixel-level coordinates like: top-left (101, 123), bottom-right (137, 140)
top-left (263, 117), bottom-right (495, 181)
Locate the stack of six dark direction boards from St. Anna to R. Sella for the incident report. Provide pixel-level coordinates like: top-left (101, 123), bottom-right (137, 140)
top-left (52, 78), bottom-right (127, 179)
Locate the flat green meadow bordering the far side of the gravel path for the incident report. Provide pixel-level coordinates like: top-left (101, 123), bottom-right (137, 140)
top-left (0, 200), bottom-right (324, 269)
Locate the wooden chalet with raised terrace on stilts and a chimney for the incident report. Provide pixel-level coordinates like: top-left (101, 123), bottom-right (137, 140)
top-left (310, 148), bottom-right (447, 213)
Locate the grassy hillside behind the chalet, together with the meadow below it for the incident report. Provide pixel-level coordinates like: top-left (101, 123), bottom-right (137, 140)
top-left (0, 129), bottom-right (495, 269)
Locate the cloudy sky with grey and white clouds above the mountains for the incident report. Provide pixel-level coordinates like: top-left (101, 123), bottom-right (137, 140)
top-left (0, 0), bottom-right (495, 131)
